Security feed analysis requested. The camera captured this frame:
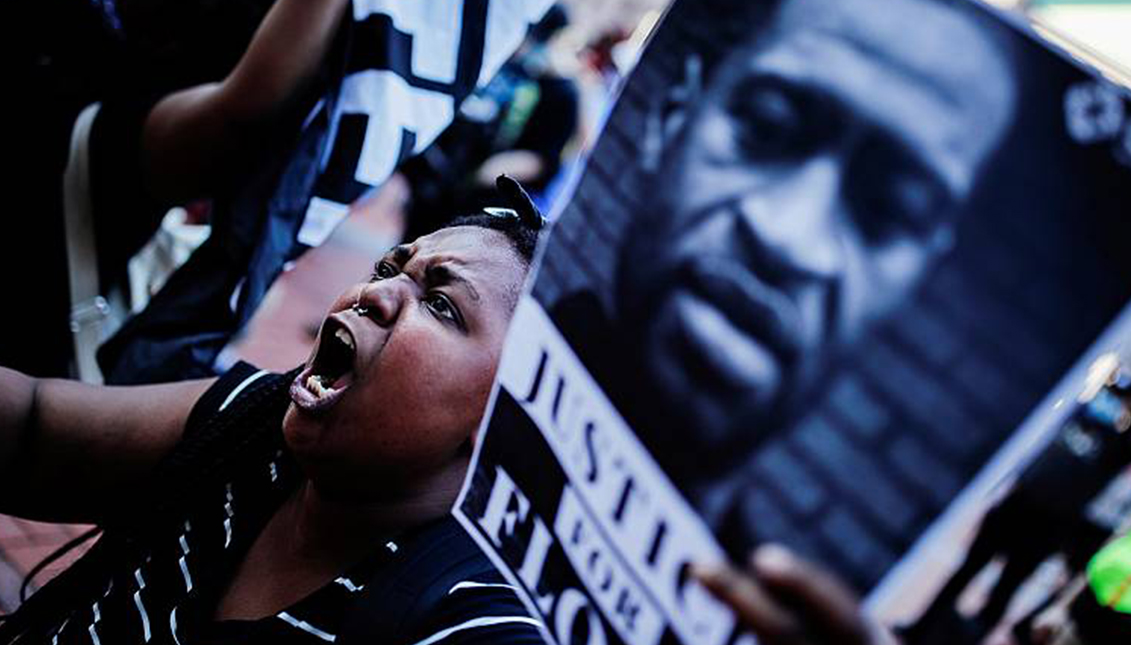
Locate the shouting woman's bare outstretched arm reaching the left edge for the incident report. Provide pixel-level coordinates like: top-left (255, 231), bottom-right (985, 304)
top-left (0, 368), bottom-right (215, 522)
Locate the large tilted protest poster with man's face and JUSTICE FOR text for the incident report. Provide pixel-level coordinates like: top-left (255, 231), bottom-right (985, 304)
top-left (456, 0), bottom-right (1131, 645)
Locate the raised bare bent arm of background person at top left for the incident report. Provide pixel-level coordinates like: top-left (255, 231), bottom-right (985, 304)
top-left (141, 0), bottom-right (349, 203)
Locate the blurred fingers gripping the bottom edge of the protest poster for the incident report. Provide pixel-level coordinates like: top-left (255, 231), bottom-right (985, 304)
top-left (692, 544), bottom-right (898, 645)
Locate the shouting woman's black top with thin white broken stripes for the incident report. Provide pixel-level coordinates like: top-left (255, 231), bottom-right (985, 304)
top-left (0, 363), bottom-right (542, 645)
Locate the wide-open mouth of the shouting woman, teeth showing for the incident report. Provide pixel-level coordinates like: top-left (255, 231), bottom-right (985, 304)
top-left (291, 317), bottom-right (357, 413)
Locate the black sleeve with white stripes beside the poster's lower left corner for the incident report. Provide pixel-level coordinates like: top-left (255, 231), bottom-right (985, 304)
top-left (406, 576), bottom-right (546, 645)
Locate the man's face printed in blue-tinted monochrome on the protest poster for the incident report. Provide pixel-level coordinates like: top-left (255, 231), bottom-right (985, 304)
top-left (616, 0), bottom-right (1013, 447)
